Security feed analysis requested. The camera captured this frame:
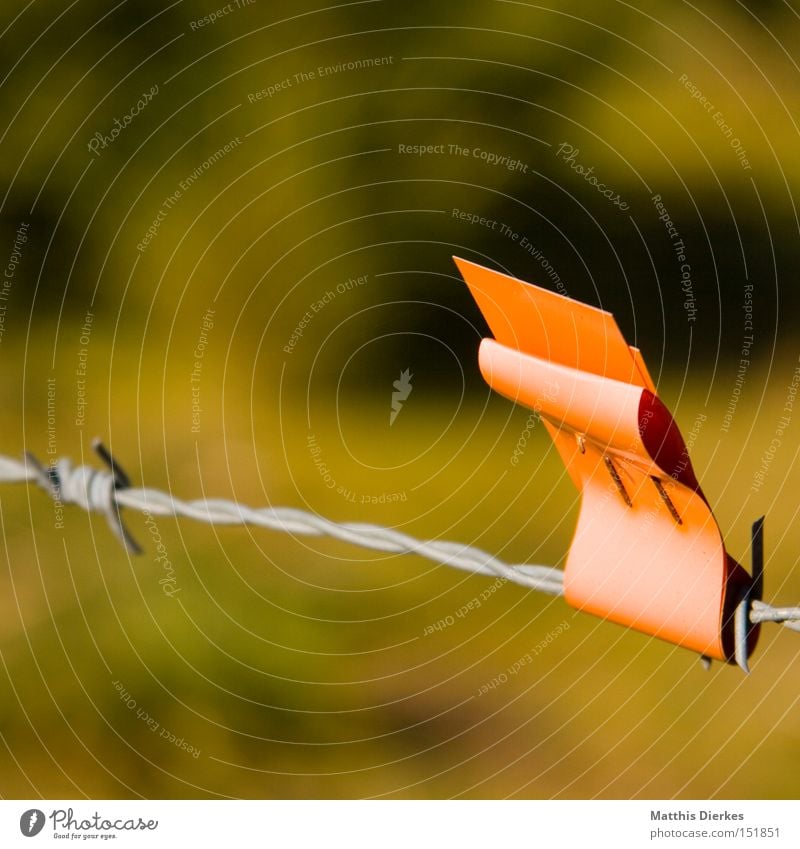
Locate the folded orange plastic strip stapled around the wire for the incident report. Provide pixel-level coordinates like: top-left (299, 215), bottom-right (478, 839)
top-left (455, 258), bottom-right (757, 660)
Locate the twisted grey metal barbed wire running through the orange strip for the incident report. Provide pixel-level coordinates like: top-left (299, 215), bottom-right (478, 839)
top-left (0, 440), bottom-right (800, 669)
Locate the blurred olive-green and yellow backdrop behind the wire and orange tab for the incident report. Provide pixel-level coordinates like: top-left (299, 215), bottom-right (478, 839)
top-left (0, 0), bottom-right (800, 798)
